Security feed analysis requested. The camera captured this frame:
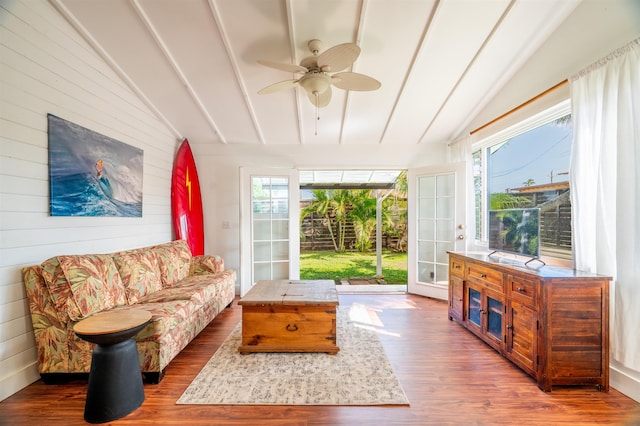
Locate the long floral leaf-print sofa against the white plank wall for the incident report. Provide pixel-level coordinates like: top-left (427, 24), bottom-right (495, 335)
top-left (22, 240), bottom-right (236, 383)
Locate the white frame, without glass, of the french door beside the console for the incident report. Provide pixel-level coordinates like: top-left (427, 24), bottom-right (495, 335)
top-left (407, 162), bottom-right (467, 300)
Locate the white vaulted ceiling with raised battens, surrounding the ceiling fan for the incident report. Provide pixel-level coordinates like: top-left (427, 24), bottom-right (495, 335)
top-left (51, 0), bottom-right (579, 146)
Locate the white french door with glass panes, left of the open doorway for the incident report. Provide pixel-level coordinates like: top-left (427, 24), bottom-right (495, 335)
top-left (240, 168), bottom-right (300, 296)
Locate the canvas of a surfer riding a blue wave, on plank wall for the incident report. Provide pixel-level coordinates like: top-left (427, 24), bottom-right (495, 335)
top-left (47, 114), bottom-right (143, 217)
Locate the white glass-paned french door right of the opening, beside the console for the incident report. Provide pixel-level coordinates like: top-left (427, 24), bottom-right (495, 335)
top-left (407, 163), bottom-right (466, 300)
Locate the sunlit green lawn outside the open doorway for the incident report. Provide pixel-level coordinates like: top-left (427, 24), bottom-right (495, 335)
top-left (300, 251), bottom-right (407, 284)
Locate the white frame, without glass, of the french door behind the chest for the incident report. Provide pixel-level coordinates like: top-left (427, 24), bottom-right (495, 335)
top-left (240, 167), bottom-right (300, 296)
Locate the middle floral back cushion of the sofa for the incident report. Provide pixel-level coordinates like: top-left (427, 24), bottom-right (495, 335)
top-left (113, 250), bottom-right (162, 305)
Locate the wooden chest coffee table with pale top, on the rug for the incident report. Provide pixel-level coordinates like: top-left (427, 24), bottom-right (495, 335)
top-left (238, 280), bottom-right (340, 354)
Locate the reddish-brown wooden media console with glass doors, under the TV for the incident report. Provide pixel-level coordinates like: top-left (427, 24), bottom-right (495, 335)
top-left (449, 252), bottom-right (611, 392)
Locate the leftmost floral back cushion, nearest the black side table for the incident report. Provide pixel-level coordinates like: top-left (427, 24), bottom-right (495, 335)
top-left (58, 254), bottom-right (126, 321)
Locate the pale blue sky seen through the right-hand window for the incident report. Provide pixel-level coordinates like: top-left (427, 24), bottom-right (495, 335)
top-left (488, 121), bottom-right (573, 194)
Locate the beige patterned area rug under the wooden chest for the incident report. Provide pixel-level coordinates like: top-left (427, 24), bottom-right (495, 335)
top-left (176, 307), bottom-right (409, 405)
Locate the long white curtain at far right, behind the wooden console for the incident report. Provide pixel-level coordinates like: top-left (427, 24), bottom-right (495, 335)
top-left (570, 39), bottom-right (640, 372)
